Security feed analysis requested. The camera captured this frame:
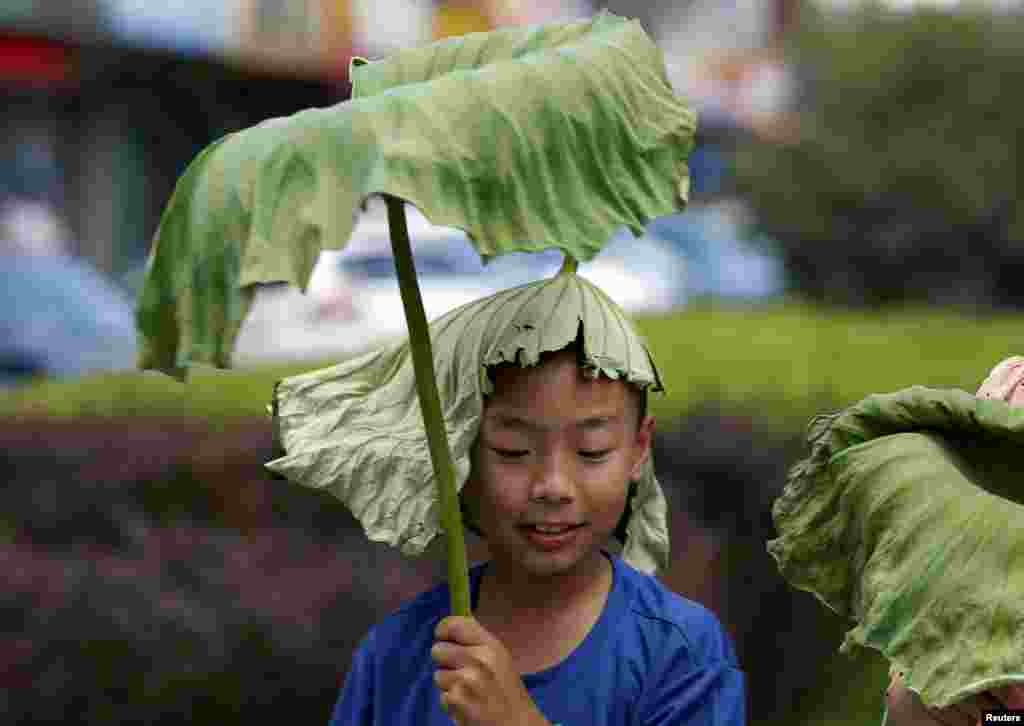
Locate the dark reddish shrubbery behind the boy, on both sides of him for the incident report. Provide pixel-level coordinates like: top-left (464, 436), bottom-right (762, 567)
top-left (0, 410), bottom-right (836, 724)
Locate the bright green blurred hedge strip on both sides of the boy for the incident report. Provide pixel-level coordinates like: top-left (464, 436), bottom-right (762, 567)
top-left (0, 303), bottom-right (1024, 430)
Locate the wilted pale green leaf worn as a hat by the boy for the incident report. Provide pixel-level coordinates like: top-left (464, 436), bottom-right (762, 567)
top-left (267, 272), bottom-right (669, 572)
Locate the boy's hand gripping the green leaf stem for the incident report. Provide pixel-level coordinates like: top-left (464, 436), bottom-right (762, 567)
top-left (430, 615), bottom-right (548, 726)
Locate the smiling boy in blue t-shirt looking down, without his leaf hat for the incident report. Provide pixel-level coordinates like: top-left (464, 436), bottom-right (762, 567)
top-left (331, 344), bottom-right (744, 726)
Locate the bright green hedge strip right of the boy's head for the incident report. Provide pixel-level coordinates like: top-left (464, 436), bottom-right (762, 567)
top-left (639, 303), bottom-right (1024, 417)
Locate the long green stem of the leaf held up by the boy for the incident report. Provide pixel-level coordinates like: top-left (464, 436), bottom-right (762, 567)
top-left (385, 195), bottom-right (470, 615)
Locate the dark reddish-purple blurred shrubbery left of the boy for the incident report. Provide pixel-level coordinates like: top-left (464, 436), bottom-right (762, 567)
top-left (0, 419), bottom-right (440, 724)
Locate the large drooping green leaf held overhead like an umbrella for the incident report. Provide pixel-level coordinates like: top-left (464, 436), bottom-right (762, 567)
top-left (137, 13), bottom-right (695, 376)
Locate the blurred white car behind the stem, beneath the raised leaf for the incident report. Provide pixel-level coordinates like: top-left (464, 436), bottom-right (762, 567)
top-left (234, 200), bottom-right (685, 366)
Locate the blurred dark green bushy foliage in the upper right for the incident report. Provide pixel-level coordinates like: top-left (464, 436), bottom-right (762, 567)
top-left (737, 6), bottom-right (1024, 308)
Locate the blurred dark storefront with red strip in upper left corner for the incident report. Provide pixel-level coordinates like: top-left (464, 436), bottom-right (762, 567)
top-left (0, 0), bottom-right (353, 286)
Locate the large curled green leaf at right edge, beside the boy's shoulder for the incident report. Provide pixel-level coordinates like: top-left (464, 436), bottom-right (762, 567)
top-left (768, 386), bottom-right (1024, 707)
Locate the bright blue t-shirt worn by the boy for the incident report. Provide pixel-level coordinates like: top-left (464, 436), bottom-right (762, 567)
top-left (331, 553), bottom-right (745, 726)
